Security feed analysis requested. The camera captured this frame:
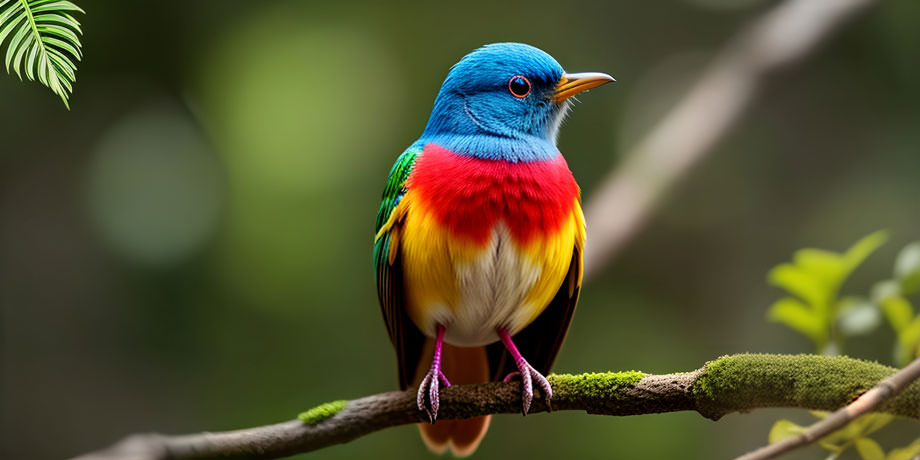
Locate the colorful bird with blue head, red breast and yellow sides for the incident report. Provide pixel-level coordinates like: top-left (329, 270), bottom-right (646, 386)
top-left (374, 43), bottom-right (614, 456)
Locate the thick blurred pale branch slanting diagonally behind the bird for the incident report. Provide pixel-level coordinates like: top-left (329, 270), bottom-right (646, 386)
top-left (585, 0), bottom-right (875, 279)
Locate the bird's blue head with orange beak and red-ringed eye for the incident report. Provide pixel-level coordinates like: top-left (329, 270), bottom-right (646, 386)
top-left (419, 43), bottom-right (614, 162)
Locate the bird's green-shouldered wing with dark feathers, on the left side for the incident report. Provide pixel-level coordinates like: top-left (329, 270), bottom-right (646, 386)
top-left (374, 146), bottom-right (425, 389)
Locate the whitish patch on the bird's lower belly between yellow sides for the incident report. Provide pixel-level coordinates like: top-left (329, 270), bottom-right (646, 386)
top-left (429, 225), bottom-right (542, 347)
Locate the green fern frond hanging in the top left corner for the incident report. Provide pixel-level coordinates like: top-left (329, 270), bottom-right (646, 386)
top-left (0, 0), bottom-right (84, 110)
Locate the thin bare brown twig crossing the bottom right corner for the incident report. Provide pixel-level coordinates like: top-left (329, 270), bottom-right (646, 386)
top-left (735, 358), bottom-right (920, 460)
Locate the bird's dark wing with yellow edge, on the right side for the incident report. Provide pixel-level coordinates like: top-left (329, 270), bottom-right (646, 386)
top-left (487, 202), bottom-right (585, 380)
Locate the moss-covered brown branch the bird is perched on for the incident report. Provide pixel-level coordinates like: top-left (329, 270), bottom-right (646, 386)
top-left (73, 354), bottom-right (920, 460)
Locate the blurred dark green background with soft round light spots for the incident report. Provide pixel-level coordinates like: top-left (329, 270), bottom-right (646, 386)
top-left (0, 0), bottom-right (920, 459)
